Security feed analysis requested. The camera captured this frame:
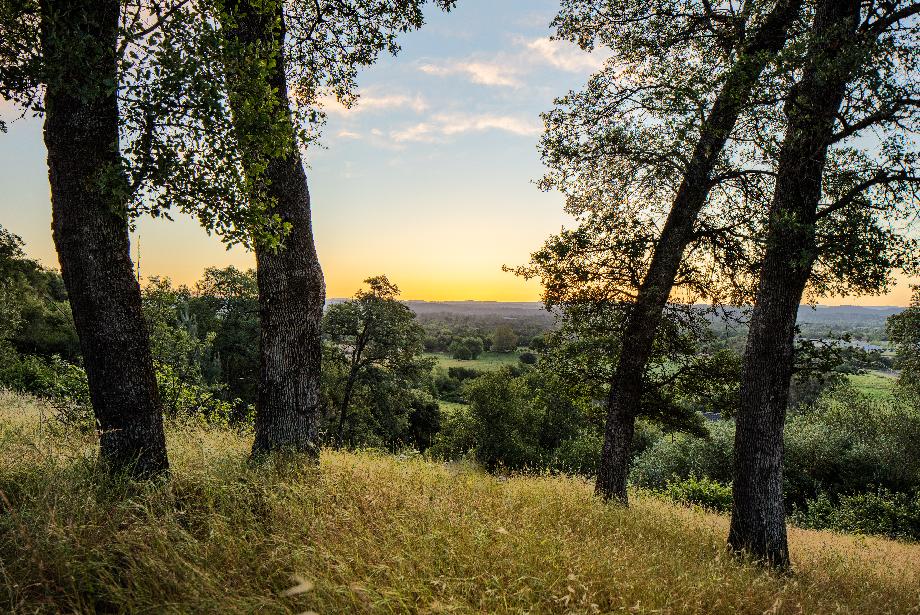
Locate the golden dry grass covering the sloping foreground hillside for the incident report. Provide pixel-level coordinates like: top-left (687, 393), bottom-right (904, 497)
top-left (0, 396), bottom-right (920, 613)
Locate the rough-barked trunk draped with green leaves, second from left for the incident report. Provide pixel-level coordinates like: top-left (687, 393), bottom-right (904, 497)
top-left (221, 0), bottom-right (326, 456)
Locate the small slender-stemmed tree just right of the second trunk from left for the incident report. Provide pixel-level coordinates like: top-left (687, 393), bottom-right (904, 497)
top-left (323, 275), bottom-right (434, 445)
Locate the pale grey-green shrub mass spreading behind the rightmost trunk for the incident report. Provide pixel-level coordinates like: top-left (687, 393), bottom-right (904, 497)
top-left (630, 383), bottom-right (920, 527)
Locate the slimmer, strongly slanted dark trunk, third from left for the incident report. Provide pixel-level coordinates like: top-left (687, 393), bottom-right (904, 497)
top-left (595, 0), bottom-right (802, 504)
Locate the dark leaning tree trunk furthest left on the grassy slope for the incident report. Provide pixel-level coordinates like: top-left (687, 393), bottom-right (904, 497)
top-left (41, 0), bottom-right (169, 477)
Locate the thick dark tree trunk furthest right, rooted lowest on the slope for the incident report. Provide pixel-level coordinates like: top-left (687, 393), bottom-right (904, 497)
top-left (728, 0), bottom-right (860, 568)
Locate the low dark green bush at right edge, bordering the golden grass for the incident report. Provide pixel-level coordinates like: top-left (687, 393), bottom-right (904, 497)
top-left (792, 490), bottom-right (920, 540)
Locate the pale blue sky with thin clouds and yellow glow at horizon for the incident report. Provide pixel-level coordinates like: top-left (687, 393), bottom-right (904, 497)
top-left (0, 0), bottom-right (916, 305)
